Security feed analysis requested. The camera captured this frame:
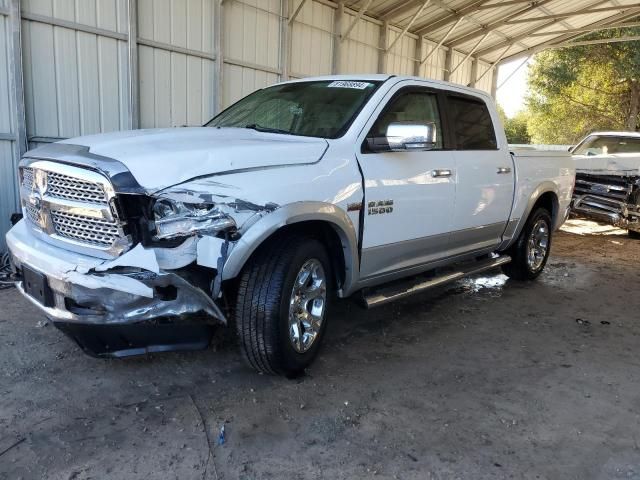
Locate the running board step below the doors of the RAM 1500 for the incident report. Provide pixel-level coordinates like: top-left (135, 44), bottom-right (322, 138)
top-left (363, 255), bottom-right (511, 308)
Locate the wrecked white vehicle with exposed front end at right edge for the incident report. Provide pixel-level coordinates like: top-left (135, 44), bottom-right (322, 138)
top-left (571, 132), bottom-right (640, 238)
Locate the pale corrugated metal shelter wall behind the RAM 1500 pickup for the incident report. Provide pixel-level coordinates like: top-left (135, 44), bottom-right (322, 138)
top-left (0, 0), bottom-right (492, 250)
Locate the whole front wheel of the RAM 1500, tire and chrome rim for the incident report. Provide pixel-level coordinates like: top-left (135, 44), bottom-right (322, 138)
top-left (235, 235), bottom-right (331, 376)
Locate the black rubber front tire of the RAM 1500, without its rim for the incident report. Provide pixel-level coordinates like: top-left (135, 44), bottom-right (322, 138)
top-left (235, 234), bottom-right (332, 376)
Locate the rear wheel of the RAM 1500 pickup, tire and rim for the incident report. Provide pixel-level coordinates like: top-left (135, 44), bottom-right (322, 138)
top-left (502, 208), bottom-right (551, 280)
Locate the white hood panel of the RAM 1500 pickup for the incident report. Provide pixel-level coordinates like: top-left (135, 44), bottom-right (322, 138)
top-left (55, 127), bottom-right (328, 191)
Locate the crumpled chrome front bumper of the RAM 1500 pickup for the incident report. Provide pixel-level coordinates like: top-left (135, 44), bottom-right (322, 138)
top-left (7, 220), bottom-right (226, 356)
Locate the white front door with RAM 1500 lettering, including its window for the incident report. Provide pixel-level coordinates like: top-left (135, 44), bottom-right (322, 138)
top-left (357, 86), bottom-right (456, 279)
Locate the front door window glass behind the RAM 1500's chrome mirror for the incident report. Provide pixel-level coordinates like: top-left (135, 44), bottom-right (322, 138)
top-left (368, 92), bottom-right (443, 149)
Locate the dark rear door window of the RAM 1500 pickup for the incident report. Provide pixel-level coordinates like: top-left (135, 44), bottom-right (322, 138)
top-left (448, 96), bottom-right (498, 150)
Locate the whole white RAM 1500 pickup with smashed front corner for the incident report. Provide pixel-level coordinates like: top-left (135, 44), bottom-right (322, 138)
top-left (7, 75), bottom-right (575, 375)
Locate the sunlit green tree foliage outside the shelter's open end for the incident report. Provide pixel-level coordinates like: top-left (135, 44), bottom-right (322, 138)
top-left (527, 24), bottom-right (640, 144)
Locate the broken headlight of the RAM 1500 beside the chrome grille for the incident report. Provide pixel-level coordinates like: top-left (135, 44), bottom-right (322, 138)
top-left (153, 198), bottom-right (236, 240)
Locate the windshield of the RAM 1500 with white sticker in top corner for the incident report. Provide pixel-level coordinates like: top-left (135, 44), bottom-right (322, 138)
top-left (205, 80), bottom-right (380, 138)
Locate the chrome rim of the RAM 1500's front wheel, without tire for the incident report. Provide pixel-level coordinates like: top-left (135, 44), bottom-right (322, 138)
top-left (289, 258), bottom-right (327, 353)
